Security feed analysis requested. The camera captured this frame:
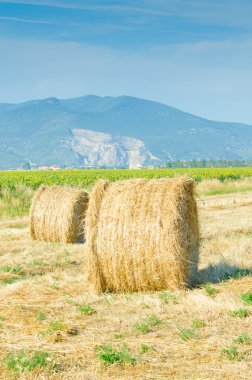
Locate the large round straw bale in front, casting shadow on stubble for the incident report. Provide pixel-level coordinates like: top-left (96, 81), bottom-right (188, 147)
top-left (85, 177), bottom-right (199, 292)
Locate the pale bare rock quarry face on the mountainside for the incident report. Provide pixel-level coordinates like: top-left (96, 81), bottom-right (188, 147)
top-left (68, 128), bottom-right (160, 168)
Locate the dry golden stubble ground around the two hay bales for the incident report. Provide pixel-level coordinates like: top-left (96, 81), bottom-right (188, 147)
top-left (0, 183), bottom-right (252, 380)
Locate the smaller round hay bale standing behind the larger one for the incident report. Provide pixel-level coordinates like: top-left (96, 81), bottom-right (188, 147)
top-left (30, 186), bottom-right (89, 243)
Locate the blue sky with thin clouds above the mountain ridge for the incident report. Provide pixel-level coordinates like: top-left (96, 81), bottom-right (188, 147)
top-left (0, 0), bottom-right (252, 124)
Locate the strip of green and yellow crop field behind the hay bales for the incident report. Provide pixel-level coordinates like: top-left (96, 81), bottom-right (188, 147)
top-left (0, 167), bottom-right (252, 190)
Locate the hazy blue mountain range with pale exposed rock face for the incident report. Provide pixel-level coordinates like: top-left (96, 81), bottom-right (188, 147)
top-left (0, 95), bottom-right (252, 169)
